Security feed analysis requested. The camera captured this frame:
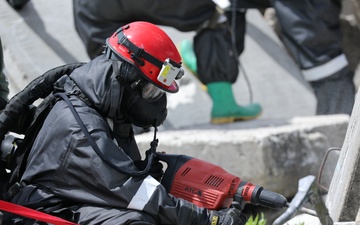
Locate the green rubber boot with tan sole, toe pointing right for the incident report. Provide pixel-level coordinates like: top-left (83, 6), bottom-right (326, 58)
top-left (207, 82), bottom-right (262, 124)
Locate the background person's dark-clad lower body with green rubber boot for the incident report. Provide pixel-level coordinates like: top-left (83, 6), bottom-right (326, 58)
top-left (73, 0), bottom-right (262, 123)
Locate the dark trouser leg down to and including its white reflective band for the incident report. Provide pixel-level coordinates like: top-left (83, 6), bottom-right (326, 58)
top-left (271, 0), bottom-right (348, 81)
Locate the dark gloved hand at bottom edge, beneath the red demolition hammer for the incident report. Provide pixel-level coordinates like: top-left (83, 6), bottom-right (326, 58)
top-left (210, 208), bottom-right (247, 225)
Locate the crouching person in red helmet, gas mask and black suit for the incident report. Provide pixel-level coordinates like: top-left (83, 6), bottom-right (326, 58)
top-left (3, 22), bottom-right (246, 225)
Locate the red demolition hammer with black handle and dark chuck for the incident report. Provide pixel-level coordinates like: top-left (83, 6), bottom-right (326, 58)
top-left (156, 153), bottom-right (289, 210)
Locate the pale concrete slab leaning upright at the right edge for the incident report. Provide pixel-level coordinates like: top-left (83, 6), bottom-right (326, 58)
top-left (326, 86), bottom-right (360, 222)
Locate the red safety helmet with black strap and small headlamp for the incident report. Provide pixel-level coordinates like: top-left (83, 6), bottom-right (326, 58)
top-left (106, 22), bottom-right (184, 93)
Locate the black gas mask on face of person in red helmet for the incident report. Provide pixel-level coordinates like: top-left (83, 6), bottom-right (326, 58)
top-left (118, 59), bottom-right (167, 128)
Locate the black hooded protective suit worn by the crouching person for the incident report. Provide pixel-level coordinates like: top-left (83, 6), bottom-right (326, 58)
top-left (4, 55), bottom-right (217, 225)
